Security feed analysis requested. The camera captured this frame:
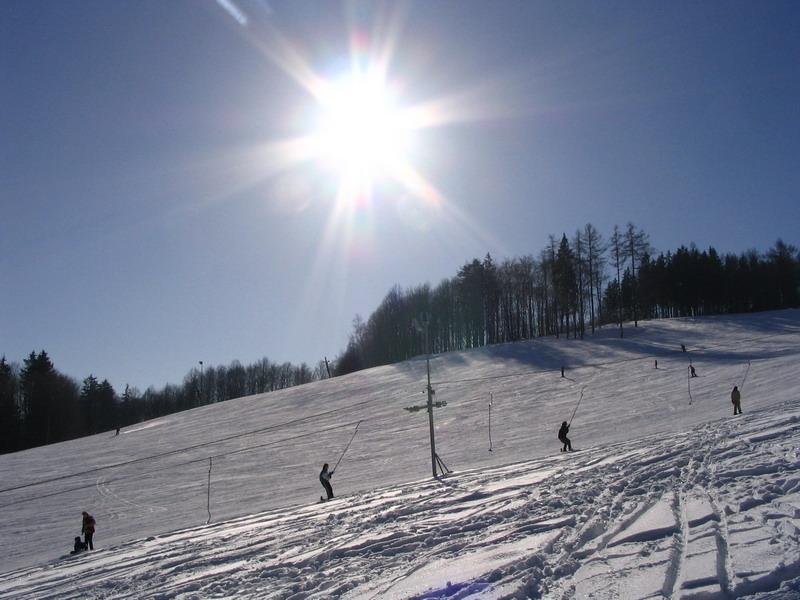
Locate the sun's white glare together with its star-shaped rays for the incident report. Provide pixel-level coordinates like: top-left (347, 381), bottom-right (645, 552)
top-left (209, 0), bottom-right (505, 328)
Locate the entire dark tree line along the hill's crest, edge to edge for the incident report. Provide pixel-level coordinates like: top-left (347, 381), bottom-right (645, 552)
top-left (0, 223), bottom-right (800, 453)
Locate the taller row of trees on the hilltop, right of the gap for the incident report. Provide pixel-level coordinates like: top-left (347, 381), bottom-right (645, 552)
top-left (336, 230), bottom-right (800, 374)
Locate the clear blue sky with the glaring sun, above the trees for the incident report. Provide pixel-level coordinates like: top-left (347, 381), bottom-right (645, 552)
top-left (0, 0), bottom-right (800, 391)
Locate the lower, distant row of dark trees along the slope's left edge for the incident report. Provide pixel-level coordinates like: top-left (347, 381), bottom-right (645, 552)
top-left (0, 350), bottom-right (327, 453)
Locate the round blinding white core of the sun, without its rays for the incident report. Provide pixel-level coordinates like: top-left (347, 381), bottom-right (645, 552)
top-left (314, 74), bottom-right (414, 185)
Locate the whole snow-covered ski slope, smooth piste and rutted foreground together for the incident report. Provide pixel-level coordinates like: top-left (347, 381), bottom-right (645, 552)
top-left (0, 311), bottom-right (800, 599)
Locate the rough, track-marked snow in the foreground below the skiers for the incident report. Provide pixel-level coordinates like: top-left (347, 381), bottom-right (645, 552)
top-left (0, 401), bottom-right (800, 599)
